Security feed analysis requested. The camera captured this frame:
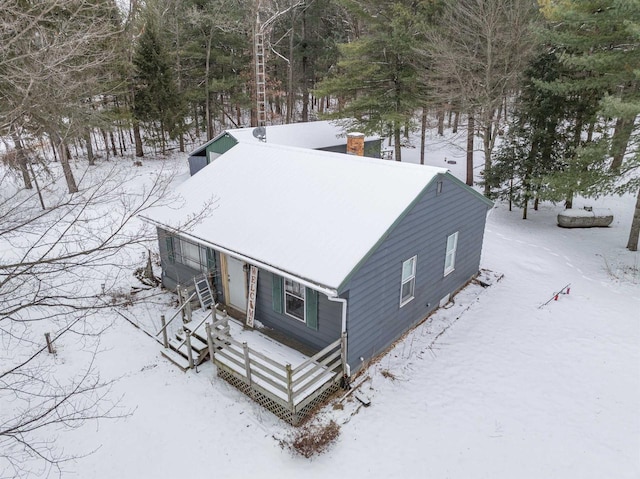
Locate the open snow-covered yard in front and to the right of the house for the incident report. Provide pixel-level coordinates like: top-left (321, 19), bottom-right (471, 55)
top-left (0, 129), bottom-right (640, 479)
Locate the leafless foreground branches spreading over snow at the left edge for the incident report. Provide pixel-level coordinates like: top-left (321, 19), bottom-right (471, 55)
top-left (0, 159), bottom-right (184, 477)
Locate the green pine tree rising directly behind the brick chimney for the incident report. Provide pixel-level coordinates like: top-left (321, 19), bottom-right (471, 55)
top-left (316, 0), bottom-right (432, 161)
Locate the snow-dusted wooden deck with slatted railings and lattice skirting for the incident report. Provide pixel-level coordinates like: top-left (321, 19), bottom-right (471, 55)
top-left (159, 306), bottom-right (346, 425)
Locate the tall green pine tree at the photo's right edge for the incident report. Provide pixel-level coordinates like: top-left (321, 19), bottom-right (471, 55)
top-left (544, 0), bottom-right (640, 251)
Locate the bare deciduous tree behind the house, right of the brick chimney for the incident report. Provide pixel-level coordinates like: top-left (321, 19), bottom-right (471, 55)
top-left (425, 0), bottom-right (535, 191)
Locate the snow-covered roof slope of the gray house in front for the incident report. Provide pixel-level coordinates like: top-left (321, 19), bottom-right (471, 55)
top-left (145, 143), bottom-right (447, 291)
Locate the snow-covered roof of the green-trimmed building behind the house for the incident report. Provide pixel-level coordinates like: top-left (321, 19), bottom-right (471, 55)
top-left (191, 121), bottom-right (380, 156)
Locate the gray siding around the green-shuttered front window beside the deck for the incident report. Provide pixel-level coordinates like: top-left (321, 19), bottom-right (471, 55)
top-left (256, 270), bottom-right (342, 351)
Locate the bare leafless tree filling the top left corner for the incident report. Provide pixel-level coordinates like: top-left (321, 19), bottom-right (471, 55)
top-left (0, 0), bottom-right (121, 193)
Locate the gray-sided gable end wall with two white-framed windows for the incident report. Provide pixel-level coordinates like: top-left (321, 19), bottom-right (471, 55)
top-left (343, 176), bottom-right (487, 372)
